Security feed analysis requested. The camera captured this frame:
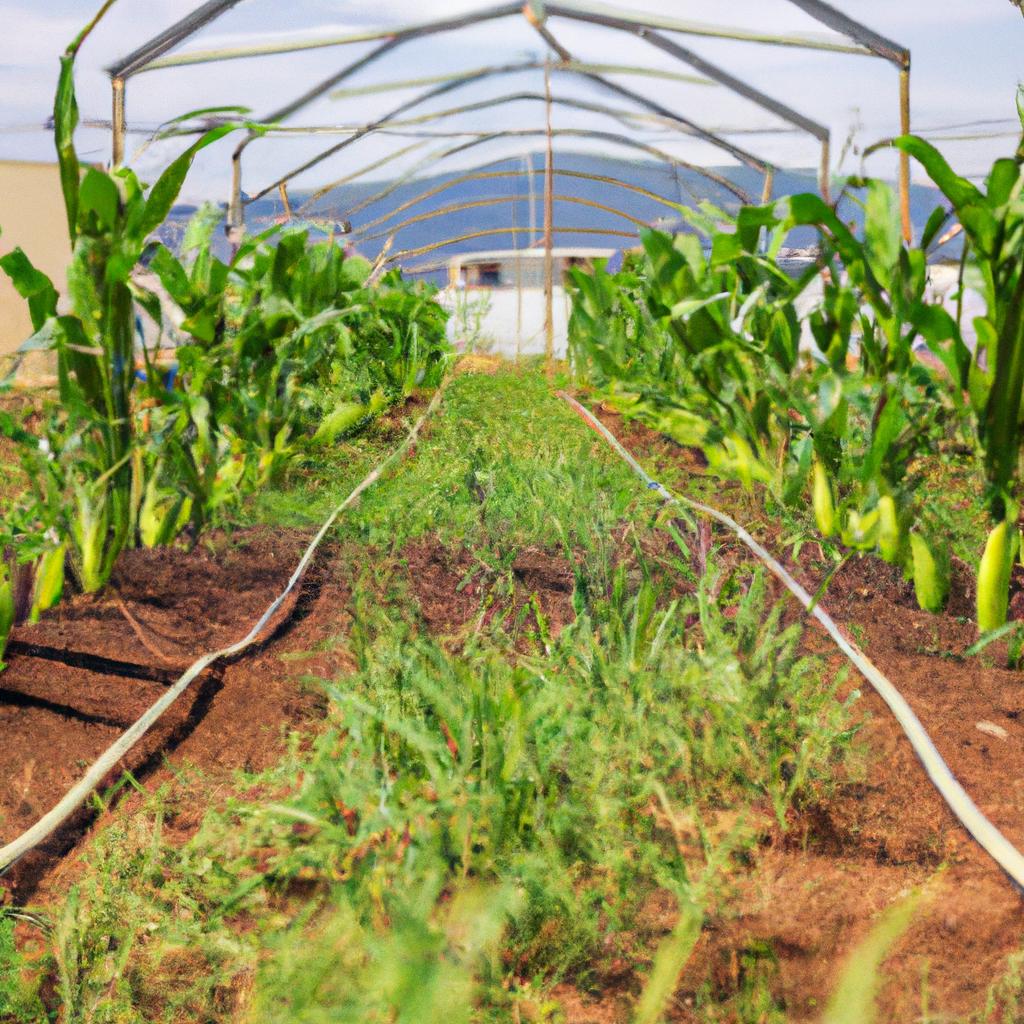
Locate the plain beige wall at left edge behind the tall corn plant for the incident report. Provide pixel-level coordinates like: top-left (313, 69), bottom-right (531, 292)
top-left (0, 161), bottom-right (71, 370)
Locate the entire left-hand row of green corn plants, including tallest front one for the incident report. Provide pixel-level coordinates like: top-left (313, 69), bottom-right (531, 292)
top-left (0, 29), bottom-right (447, 656)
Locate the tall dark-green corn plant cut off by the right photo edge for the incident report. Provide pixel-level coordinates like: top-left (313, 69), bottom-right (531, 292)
top-left (895, 91), bottom-right (1024, 633)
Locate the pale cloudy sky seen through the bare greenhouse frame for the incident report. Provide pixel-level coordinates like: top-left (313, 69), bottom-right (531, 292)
top-left (0, 0), bottom-right (1024, 201)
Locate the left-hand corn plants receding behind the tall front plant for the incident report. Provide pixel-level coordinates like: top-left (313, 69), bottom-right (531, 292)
top-left (150, 214), bottom-right (447, 491)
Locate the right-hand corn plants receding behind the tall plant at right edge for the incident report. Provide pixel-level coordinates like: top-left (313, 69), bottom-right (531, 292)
top-left (570, 181), bottom-right (958, 609)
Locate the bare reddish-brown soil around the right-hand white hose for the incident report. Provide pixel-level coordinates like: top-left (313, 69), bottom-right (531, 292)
top-left (589, 403), bottom-right (1024, 1024)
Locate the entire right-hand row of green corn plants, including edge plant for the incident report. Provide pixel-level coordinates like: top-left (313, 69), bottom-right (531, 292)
top-left (569, 97), bottom-right (1024, 633)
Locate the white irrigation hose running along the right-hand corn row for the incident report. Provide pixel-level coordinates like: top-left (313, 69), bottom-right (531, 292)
top-left (558, 391), bottom-right (1024, 889)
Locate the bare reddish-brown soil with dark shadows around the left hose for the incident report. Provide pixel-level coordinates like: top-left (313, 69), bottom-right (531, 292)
top-left (0, 530), bottom-right (348, 903)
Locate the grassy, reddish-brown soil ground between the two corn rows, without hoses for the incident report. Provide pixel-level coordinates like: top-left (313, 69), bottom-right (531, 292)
top-left (6, 366), bottom-right (1024, 1022)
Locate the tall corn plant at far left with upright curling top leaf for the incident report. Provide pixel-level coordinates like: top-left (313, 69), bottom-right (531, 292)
top-left (0, 4), bottom-right (234, 592)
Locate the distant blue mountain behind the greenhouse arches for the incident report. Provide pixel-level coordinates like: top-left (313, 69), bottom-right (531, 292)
top-left (157, 154), bottom-right (941, 280)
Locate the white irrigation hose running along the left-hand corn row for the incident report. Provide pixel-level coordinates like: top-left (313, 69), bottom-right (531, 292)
top-left (0, 378), bottom-right (450, 873)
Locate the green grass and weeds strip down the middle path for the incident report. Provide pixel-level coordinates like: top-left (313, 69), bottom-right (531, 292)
top-left (0, 372), bottom-right (850, 1024)
